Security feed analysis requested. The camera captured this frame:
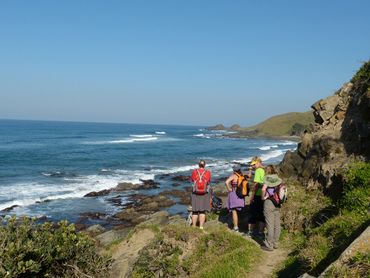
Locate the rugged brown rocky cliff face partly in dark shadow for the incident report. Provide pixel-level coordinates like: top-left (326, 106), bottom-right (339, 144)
top-left (279, 61), bottom-right (370, 193)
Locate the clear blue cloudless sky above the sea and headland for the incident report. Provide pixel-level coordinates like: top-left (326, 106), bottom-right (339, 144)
top-left (0, 0), bottom-right (370, 126)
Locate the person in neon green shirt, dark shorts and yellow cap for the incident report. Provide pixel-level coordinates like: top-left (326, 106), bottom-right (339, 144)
top-left (248, 157), bottom-right (265, 238)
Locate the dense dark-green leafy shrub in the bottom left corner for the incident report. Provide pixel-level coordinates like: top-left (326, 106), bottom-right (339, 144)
top-left (0, 217), bottom-right (111, 277)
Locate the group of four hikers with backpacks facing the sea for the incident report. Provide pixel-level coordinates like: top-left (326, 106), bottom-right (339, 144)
top-left (191, 157), bottom-right (286, 251)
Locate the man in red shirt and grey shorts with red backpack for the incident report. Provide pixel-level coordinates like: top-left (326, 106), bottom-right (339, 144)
top-left (191, 160), bottom-right (211, 229)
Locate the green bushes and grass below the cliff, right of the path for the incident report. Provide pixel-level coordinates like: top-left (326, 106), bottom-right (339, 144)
top-left (277, 162), bottom-right (370, 277)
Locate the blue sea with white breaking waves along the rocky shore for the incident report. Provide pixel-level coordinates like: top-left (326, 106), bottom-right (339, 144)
top-left (0, 120), bottom-right (296, 224)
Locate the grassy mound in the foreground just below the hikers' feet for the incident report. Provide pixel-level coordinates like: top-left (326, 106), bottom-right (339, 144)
top-left (133, 225), bottom-right (261, 277)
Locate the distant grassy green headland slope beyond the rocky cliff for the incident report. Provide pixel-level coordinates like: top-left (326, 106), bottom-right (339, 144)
top-left (243, 111), bottom-right (314, 136)
